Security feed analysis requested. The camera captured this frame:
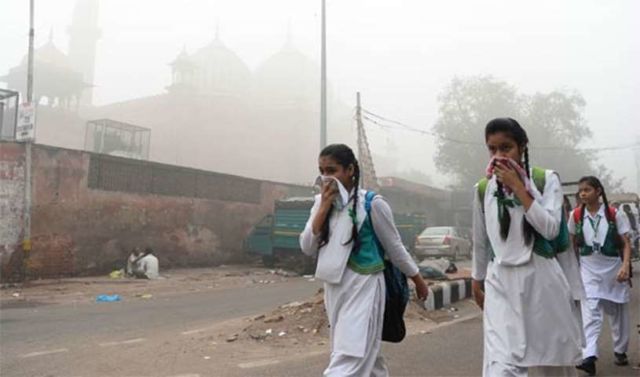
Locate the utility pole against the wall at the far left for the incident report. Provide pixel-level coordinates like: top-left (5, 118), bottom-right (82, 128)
top-left (21, 0), bottom-right (35, 279)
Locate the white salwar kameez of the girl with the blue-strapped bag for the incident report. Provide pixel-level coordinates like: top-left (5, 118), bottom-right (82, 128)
top-left (300, 190), bottom-right (418, 377)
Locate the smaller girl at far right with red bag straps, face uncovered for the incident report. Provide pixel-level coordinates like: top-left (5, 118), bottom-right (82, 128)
top-left (569, 176), bottom-right (631, 376)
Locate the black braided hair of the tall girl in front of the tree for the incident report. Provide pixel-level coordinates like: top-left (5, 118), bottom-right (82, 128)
top-left (484, 118), bottom-right (536, 245)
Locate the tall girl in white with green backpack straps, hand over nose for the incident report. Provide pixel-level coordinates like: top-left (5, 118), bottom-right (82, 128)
top-left (472, 118), bottom-right (584, 377)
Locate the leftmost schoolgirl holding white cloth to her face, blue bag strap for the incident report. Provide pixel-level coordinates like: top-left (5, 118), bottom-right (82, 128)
top-left (300, 144), bottom-right (428, 377)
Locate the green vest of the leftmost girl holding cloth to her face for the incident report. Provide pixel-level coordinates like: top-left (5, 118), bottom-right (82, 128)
top-left (347, 191), bottom-right (384, 275)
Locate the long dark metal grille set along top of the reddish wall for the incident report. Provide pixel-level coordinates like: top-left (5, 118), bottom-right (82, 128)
top-left (88, 154), bottom-right (261, 204)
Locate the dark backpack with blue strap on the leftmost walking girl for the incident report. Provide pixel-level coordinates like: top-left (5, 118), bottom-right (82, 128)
top-left (364, 191), bottom-right (409, 343)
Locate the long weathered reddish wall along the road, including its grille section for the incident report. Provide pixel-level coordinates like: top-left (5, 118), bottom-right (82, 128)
top-left (0, 143), bottom-right (309, 277)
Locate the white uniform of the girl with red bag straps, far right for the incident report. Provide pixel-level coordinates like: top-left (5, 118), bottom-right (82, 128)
top-left (568, 204), bottom-right (631, 358)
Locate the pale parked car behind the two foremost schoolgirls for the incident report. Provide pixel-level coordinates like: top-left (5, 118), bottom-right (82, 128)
top-left (414, 226), bottom-right (471, 260)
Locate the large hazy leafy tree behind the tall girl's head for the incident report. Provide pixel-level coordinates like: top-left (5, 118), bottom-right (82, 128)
top-left (434, 76), bottom-right (621, 189)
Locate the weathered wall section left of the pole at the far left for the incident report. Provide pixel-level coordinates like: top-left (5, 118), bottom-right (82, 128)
top-left (0, 142), bottom-right (25, 278)
